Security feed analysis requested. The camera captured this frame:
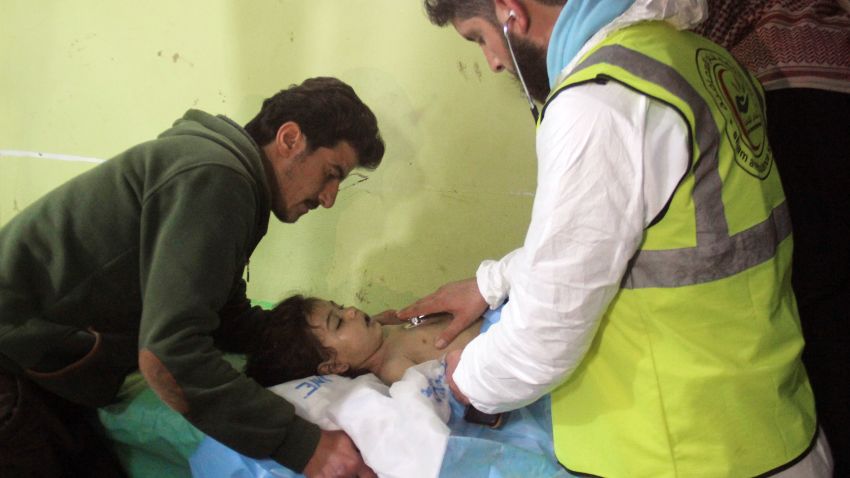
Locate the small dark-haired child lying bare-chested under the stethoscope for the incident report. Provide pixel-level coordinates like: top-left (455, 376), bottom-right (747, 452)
top-left (245, 295), bottom-right (481, 387)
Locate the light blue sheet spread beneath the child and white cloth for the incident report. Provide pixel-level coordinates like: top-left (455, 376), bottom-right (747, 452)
top-left (189, 310), bottom-right (572, 478)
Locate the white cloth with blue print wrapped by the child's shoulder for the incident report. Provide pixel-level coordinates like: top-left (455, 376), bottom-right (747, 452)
top-left (269, 360), bottom-right (451, 478)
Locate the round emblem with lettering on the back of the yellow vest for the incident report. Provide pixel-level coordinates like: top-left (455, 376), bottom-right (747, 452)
top-left (697, 48), bottom-right (773, 179)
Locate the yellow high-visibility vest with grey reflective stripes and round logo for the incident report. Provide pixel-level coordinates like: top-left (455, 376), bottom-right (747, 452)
top-left (540, 22), bottom-right (817, 478)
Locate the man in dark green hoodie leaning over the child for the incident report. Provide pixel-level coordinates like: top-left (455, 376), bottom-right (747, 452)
top-left (0, 78), bottom-right (384, 476)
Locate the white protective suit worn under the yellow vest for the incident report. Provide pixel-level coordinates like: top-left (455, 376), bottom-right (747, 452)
top-left (453, 0), bottom-right (706, 413)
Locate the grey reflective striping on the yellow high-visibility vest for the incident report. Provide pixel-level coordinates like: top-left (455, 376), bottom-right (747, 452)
top-left (560, 45), bottom-right (791, 289)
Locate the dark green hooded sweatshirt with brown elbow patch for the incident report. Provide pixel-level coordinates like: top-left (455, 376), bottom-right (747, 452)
top-left (0, 110), bottom-right (320, 471)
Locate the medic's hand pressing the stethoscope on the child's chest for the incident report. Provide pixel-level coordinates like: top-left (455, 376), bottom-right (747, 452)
top-left (398, 277), bottom-right (487, 349)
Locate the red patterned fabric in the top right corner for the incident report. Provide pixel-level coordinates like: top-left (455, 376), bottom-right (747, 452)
top-left (694, 0), bottom-right (850, 93)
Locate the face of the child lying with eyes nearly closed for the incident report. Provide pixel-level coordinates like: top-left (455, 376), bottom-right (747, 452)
top-left (307, 300), bottom-right (383, 374)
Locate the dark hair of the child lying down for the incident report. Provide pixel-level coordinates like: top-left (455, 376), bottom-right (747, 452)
top-left (245, 295), bottom-right (334, 387)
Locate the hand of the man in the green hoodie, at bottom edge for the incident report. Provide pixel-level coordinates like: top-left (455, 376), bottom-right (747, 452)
top-left (304, 430), bottom-right (378, 478)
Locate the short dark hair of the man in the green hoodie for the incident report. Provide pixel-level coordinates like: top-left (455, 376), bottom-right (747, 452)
top-left (245, 77), bottom-right (384, 169)
